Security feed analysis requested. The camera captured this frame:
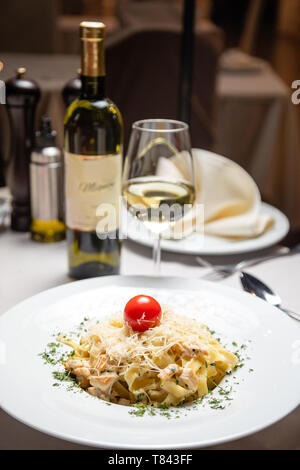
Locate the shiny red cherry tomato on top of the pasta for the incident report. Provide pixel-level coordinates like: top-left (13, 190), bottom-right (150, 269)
top-left (124, 295), bottom-right (161, 332)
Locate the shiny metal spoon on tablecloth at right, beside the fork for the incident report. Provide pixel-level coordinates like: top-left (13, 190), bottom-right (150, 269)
top-left (240, 271), bottom-right (300, 321)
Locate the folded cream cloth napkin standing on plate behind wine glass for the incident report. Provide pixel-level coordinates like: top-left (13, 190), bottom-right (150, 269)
top-left (157, 149), bottom-right (274, 238)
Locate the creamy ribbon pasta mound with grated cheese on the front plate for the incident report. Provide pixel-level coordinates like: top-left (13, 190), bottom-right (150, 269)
top-left (58, 296), bottom-right (238, 407)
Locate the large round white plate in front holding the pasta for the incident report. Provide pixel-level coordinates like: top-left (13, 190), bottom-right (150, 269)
top-left (0, 276), bottom-right (300, 449)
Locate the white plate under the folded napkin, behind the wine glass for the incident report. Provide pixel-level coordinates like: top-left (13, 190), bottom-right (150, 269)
top-left (124, 203), bottom-right (290, 256)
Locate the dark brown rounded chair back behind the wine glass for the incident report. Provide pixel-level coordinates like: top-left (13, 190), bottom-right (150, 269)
top-left (106, 25), bottom-right (223, 149)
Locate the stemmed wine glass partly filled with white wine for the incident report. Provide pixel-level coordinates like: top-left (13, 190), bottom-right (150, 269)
top-left (123, 119), bottom-right (195, 274)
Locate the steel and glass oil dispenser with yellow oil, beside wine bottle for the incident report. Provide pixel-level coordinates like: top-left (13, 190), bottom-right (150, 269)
top-left (30, 116), bottom-right (65, 243)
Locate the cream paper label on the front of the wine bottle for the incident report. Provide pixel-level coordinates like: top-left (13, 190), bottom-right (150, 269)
top-left (65, 152), bottom-right (122, 232)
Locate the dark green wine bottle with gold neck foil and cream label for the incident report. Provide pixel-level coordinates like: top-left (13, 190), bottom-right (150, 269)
top-left (64, 21), bottom-right (123, 279)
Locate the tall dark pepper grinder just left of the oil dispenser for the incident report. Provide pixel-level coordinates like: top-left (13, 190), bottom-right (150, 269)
top-left (6, 67), bottom-right (40, 232)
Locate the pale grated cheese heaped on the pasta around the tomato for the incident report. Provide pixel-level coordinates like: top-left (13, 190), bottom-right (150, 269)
top-left (82, 307), bottom-right (220, 372)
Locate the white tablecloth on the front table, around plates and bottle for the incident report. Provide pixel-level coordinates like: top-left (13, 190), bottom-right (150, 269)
top-left (0, 230), bottom-right (300, 450)
